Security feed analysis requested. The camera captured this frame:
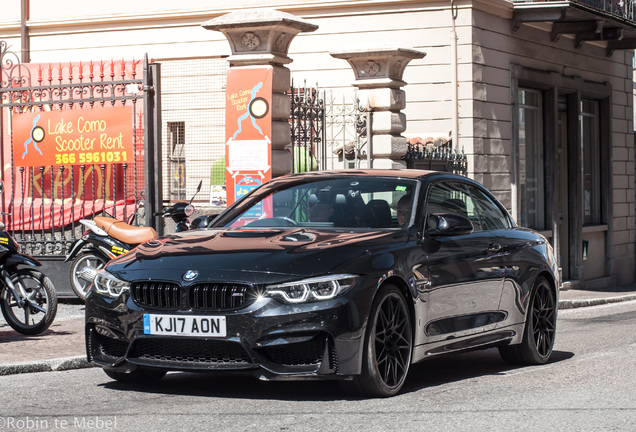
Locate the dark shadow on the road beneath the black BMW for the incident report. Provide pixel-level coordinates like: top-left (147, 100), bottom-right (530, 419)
top-left (101, 349), bottom-right (574, 401)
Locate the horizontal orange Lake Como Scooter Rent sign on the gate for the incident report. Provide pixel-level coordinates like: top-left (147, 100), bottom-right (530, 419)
top-left (11, 106), bottom-right (134, 167)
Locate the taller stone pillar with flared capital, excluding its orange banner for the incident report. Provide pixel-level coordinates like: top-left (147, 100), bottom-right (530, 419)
top-left (202, 9), bottom-right (318, 177)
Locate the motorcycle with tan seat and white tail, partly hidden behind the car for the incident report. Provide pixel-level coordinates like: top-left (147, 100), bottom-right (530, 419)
top-left (64, 182), bottom-right (202, 300)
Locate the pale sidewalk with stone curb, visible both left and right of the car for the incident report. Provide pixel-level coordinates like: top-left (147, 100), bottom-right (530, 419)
top-left (0, 285), bottom-right (636, 375)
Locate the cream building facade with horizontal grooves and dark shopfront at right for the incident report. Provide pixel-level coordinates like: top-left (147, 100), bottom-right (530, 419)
top-left (0, 0), bottom-right (636, 287)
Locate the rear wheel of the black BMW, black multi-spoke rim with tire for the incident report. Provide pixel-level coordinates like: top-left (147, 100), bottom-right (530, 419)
top-left (499, 276), bottom-right (557, 365)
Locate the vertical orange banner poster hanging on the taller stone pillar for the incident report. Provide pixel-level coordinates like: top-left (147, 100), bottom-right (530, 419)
top-left (225, 66), bottom-right (273, 213)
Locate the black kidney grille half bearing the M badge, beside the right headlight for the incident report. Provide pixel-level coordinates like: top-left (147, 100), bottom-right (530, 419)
top-left (188, 283), bottom-right (255, 310)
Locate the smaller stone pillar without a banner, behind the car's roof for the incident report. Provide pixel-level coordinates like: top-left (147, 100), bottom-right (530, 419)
top-left (330, 43), bottom-right (426, 169)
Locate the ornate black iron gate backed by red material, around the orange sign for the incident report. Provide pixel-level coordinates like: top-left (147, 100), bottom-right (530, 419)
top-left (0, 41), bottom-right (161, 259)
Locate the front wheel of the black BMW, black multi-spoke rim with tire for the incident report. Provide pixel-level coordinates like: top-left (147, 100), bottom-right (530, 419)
top-left (340, 284), bottom-right (413, 397)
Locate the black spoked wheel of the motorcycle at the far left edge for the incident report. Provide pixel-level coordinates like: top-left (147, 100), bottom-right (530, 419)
top-left (0, 269), bottom-right (57, 335)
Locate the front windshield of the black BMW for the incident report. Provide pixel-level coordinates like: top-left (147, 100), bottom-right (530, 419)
top-left (215, 177), bottom-right (418, 228)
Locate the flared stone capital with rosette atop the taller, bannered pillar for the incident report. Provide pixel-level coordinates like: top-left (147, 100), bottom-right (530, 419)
top-left (202, 9), bottom-right (318, 66)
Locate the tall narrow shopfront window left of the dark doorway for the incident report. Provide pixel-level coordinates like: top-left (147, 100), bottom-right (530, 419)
top-left (517, 88), bottom-right (545, 230)
